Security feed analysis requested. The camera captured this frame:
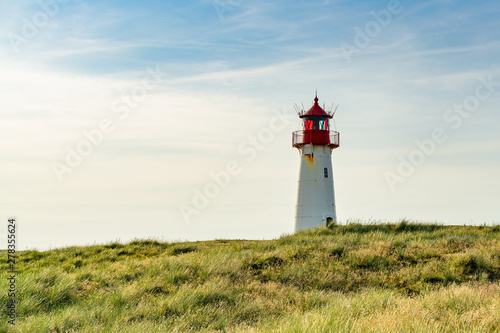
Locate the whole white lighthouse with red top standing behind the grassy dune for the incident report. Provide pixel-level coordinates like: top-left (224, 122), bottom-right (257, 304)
top-left (292, 94), bottom-right (339, 232)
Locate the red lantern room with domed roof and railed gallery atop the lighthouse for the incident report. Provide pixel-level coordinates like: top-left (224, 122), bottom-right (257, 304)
top-left (292, 95), bottom-right (339, 149)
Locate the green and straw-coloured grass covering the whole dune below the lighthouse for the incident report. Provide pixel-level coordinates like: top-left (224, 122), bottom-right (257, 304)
top-left (0, 221), bottom-right (500, 333)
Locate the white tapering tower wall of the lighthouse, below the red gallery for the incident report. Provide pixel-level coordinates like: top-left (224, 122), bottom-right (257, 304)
top-left (294, 144), bottom-right (337, 232)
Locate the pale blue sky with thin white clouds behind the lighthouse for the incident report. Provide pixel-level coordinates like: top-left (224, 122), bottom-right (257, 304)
top-left (0, 0), bottom-right (500, 250)
